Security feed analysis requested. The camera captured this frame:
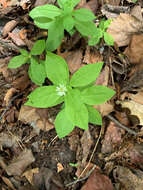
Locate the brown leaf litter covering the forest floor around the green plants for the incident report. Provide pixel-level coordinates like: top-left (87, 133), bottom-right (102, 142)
top-left (0, 0), bottom-right (143, 190)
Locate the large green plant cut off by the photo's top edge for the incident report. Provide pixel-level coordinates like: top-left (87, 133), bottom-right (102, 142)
top-left (29, 0), bottom-right (101, 51)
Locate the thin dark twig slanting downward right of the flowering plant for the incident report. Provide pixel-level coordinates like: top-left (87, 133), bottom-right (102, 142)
top-left (106, 115), bottom-right (138, 136)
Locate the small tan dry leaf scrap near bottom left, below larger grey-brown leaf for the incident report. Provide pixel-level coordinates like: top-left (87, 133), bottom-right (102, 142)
top-left (22, 168), bottom-right (39, 185)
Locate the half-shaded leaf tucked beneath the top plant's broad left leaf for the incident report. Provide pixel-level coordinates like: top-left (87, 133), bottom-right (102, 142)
top-left (34, 17), bottom-right (54, 29)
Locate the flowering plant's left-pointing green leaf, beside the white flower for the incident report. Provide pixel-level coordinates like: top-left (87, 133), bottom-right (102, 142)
top-left (25, 86), bottom-right (63, 108)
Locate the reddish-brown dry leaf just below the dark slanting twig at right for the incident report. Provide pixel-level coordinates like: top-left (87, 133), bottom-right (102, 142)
top-left (101, 122), bottom-right (124, 153)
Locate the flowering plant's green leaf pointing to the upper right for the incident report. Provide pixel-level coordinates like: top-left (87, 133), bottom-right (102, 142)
top-left (70, 62), bottom-right (103, 87)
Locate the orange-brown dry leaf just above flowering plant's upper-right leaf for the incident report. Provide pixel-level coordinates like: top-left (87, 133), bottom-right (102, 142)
top-left (83, 46), bottom-right (103, 64)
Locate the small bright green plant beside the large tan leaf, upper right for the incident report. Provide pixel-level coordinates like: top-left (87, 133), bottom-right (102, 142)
top-left (89, 19), bottom-right (114, 46)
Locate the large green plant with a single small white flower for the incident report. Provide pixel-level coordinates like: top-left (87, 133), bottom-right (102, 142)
top-left (25, 52), bottom-right (115, 138)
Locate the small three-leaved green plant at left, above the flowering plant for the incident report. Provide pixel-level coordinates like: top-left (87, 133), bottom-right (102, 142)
top-left (8, 40), bottom-right (46, 86)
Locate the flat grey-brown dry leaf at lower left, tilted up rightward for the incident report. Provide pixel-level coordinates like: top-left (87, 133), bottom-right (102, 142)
top-left (5, 149), bottom-right (35, 176)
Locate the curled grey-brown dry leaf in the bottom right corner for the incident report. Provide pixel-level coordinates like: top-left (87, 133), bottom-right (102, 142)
top-left (113, 166), bottom-right (143, 190)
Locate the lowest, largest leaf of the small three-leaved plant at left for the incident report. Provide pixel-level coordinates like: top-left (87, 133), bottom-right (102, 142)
top-left (28, 57), bottom-right (46, 86)
